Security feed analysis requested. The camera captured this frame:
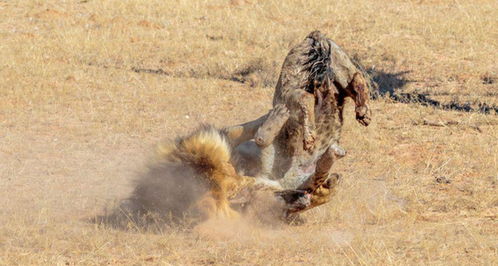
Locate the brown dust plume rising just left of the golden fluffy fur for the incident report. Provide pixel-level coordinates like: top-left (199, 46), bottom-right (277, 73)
top-left (95, 157), bottom-right (207, 229)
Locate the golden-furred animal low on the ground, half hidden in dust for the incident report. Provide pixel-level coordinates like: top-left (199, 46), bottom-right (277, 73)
top-left (126, 125), bottom-right (311, 220)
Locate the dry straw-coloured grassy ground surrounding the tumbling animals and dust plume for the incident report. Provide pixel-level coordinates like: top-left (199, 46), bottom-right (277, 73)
top-left (0, 0), bottom-right (498, 265)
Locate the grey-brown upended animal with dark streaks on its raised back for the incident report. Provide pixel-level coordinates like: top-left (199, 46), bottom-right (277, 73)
top-left (225, 31), bottom-right (371, 215)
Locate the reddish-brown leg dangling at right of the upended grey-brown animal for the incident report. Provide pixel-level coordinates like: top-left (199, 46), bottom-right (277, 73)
top-left (347, 72), bottom-right (372, 126)
